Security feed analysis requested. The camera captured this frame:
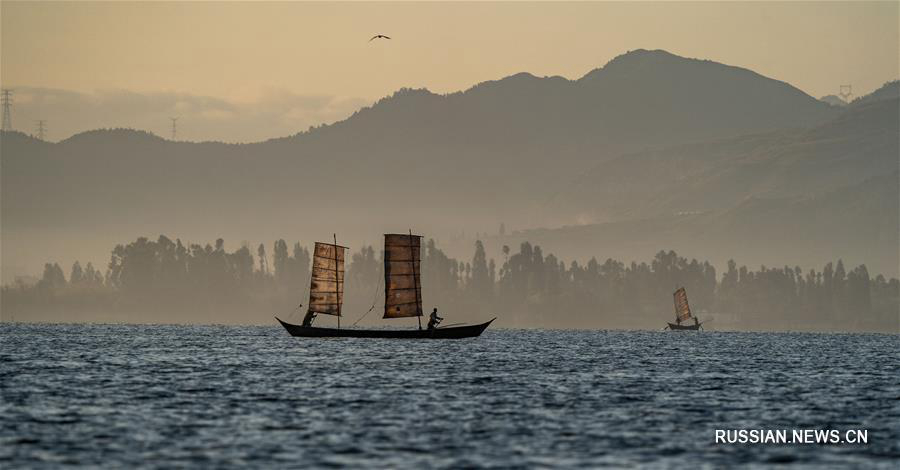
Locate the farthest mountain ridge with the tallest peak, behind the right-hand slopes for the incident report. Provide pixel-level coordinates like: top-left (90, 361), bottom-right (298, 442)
top-left (0, 50), bottom-right (872, 280)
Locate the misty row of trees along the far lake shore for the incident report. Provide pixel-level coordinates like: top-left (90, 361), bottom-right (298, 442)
top-left (0, 236), bottom-right (900, 333)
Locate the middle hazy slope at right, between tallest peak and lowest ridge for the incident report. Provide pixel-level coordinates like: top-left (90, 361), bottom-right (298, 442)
top-left (551, 99), bottom-right (900, 222)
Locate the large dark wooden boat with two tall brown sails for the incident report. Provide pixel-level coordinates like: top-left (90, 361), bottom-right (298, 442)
top-left (275, 232), bottom-right (496, 339)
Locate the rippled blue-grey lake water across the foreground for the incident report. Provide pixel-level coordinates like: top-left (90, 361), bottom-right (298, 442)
top-left (0, 324), bottom-right (900, 468)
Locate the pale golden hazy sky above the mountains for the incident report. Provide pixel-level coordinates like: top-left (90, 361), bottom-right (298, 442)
top-left (0, 1), bottom-right (900, 141)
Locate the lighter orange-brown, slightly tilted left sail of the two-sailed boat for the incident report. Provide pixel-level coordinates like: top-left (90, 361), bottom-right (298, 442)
top-left (309, 242), bottom-right (347, 317)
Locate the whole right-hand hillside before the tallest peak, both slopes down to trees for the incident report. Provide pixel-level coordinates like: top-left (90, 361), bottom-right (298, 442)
top-left (500, 98), bottom-right (900, 276)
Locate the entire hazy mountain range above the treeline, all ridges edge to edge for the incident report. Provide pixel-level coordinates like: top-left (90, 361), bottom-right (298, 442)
top-left (0, 50), bottom-right (898, 282)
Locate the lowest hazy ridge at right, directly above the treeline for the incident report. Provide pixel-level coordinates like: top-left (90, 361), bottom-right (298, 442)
top-left (485, 170), bottom-right (900, 277)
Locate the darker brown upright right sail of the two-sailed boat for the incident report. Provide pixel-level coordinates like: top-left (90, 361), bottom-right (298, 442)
top-left (384, 234), bottom-right (422, 318)
